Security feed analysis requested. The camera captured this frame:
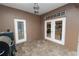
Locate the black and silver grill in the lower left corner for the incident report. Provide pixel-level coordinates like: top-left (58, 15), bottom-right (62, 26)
top-left (0, 32), bottom-right (16, 56)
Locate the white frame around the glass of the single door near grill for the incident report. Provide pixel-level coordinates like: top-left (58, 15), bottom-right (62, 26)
top-left (14, 19), bottom-right (27, 44)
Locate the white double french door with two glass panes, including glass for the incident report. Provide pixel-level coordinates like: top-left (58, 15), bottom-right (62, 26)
top-left (45, 17), bottom-right (66, 45)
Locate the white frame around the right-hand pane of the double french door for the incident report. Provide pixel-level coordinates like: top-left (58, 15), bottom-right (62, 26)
top-left (53, 17), bottom-right (66, 45)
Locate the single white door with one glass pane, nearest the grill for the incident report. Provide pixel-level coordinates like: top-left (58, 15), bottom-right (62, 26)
top-left (14, 19), bottom-right (26, 44)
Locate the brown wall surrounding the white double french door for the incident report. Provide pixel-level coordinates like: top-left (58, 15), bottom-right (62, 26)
top-left (41, 4), bottom-right (79, 51)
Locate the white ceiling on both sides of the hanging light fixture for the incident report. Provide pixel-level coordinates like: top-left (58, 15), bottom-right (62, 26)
top-left (2, 3), bottom-right (67, 15)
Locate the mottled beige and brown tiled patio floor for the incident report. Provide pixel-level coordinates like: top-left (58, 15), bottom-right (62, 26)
top-left (16, 40), bottom-right (76, 56)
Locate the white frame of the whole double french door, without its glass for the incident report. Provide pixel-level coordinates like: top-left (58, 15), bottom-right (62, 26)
top-left (44, 17), bottom-right (66, 45)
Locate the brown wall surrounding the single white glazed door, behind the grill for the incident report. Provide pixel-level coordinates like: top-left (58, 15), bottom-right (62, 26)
top-left (0, 5), bottom-right (41, 41)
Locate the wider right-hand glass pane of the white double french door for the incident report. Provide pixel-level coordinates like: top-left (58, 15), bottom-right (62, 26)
top-left (55, 21), bottom-right (62, 40)
